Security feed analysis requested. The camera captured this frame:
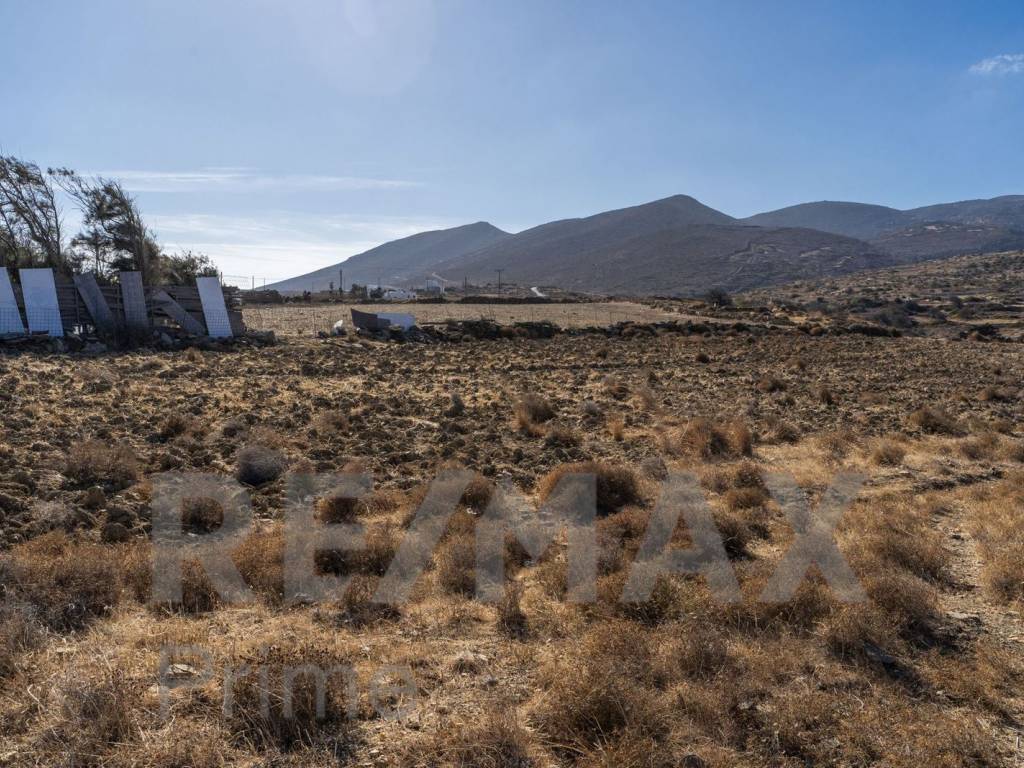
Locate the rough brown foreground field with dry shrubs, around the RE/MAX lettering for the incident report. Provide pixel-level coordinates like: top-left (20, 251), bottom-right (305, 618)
top-left (0, 304), bottom-right (1024, 768)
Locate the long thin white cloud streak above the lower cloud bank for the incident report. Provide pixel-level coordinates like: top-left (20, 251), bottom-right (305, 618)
top-left (87, 168), bottom-right (422, 193)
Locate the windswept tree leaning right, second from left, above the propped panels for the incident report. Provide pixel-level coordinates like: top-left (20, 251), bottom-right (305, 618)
top-left (50, 168), bottom-right (161, 283)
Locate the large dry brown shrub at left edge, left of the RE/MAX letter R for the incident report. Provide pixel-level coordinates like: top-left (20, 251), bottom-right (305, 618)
top-left (0, 531), bottom-right (122, 632)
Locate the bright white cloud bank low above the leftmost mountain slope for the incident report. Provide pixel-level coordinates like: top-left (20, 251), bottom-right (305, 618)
top-left (146, 212), bottom-right (456, 285)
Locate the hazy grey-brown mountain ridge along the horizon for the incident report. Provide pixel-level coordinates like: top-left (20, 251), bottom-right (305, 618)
top-left (267, 195), bottom-right (1024, 295)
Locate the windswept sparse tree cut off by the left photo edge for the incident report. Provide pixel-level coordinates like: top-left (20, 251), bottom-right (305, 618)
top-left (0, 156), bottom-right (70, 271)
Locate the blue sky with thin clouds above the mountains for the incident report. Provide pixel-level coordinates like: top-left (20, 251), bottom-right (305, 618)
top-left (0, 0), bottom-right (1024, 284)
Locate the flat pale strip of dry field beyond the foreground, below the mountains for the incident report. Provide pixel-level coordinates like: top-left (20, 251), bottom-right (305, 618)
top-left (235, 301), bottom-right (675, 336)
